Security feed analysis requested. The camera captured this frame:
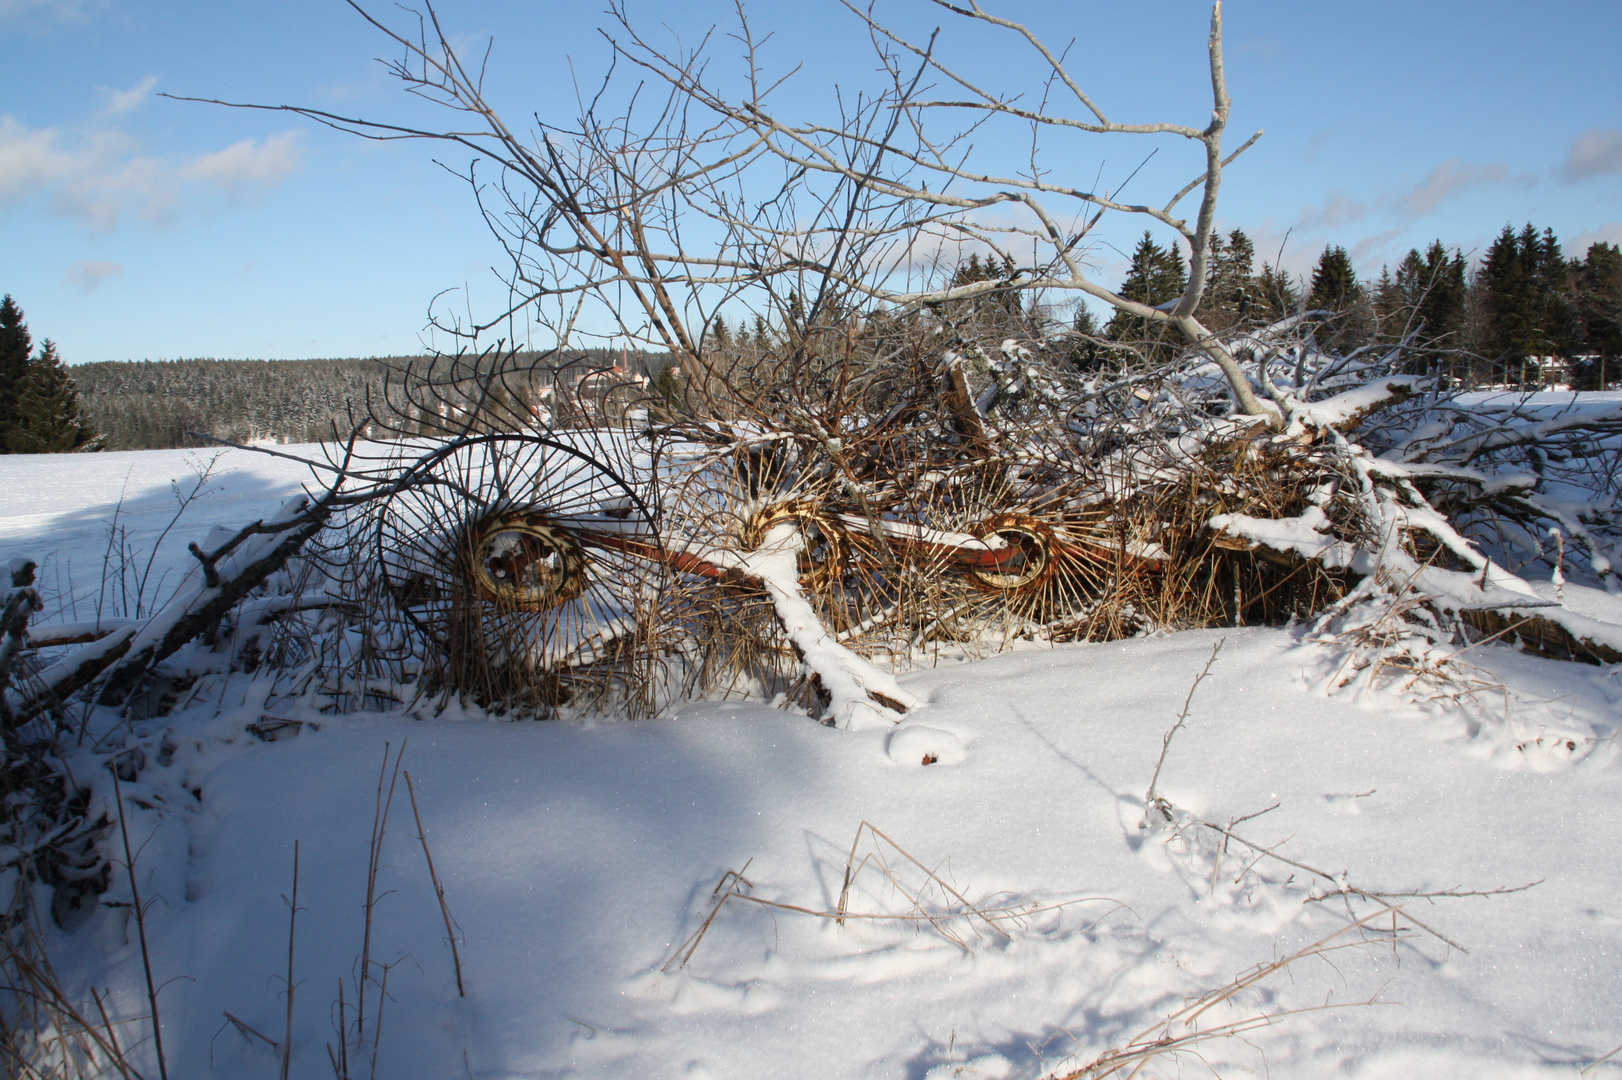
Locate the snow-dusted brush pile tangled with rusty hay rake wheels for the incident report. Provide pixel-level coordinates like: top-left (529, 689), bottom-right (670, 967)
top-left (60, 317), bottom-right (1616, 726)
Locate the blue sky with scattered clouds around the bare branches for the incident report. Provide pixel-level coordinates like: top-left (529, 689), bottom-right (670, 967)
top-left (0, 0), bottom-right (1622, 362)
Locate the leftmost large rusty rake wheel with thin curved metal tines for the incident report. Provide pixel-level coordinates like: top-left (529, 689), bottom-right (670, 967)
top-left (373, 435), bottom-right (663, 714)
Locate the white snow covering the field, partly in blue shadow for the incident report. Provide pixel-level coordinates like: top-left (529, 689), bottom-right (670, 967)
top-left (0, 448), bottom-right (1622, 1080)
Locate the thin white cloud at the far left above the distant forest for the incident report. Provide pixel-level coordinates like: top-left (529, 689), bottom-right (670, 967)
top-left (0, 110), bottom-right (302, 232)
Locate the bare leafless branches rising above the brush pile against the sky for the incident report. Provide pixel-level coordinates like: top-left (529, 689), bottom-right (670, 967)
top-left (171, 0), bottom-right (1281, 423)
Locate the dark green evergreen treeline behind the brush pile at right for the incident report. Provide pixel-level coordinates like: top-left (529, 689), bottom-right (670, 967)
top-left (1075, 224), bottom-right (1622, 389)
